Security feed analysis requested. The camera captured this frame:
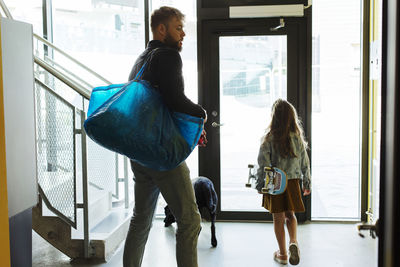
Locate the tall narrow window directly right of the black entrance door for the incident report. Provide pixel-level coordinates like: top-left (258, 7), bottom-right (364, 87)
top-left (311, 0), bottom-right (361, 220)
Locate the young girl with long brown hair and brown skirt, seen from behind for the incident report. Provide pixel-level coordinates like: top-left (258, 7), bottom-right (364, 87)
top-left (256, 99), bottom-right (310, 265)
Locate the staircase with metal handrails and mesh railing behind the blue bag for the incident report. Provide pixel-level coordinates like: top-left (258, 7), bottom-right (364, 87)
top-left (0, 0), bottom-right (132, 261)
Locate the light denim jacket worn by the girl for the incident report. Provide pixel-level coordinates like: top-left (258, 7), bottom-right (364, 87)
top-left (256, 133), bottom-right (311, 192)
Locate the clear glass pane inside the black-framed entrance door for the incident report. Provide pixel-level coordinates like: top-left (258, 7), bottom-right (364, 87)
top-left (219, 35), bottom-right (287, 214)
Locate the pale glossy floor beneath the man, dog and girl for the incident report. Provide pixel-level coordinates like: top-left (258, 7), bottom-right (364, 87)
top-left (32, 219), bottom-right (378, 267)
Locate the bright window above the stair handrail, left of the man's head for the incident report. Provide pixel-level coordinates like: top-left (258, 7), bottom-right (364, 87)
top-left (53, 0), bottom-right (145, 82)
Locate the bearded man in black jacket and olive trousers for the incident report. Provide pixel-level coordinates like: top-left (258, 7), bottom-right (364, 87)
top-left (123, 7), bottom-right (207, 267)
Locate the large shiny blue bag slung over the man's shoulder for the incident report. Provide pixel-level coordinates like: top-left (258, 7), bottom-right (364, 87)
top-left (84, 63), bottom-right (203, 171)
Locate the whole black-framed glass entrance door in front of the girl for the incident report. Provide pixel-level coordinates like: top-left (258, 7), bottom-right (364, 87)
top-left (199, 19), bottom-right (306, 220)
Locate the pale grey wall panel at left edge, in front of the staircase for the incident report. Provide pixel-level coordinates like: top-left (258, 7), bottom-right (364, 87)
top-left (0, 18), bottom-right (37, 217)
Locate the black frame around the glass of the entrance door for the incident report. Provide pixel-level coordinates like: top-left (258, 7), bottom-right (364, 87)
top-left (198, 15), bottom-right (311, 222)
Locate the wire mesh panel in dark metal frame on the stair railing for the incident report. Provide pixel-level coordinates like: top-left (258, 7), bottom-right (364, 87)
top-left (35, 80), bottom-right (76, 228)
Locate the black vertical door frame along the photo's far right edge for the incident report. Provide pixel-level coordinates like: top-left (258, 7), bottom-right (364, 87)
top-left (378, 0), bottom-right (400, 267)
